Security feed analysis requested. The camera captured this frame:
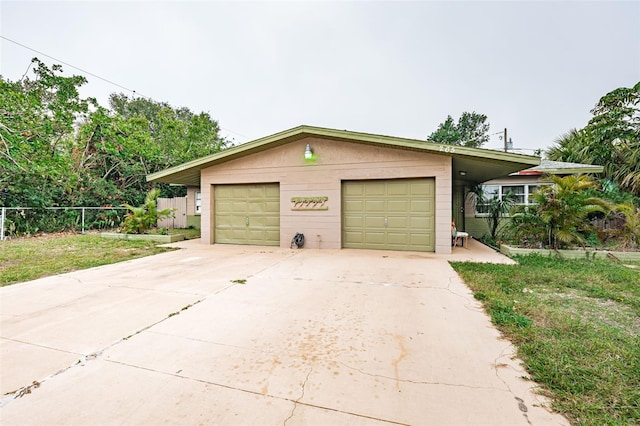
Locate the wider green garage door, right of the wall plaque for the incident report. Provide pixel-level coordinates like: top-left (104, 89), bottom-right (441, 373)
top-left (342, 179), bottom-right (435, 251)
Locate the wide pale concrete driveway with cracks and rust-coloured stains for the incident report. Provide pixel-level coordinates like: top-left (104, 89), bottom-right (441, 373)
top-left (0, 241), bottom-right (568, 426)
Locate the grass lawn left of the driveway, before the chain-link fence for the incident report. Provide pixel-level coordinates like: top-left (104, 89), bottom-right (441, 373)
top-left (0, 229), bottom-right (200, 286)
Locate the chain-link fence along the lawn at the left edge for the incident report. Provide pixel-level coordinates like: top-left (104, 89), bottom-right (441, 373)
top-left (0, 207), bottom-right (127, 240)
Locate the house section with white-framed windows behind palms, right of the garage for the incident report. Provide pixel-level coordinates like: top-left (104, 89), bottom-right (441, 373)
top-left (464, 160), bottom-right (603, 238)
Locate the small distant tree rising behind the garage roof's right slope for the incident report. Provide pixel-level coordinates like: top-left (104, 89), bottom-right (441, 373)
top-left (427, 112), bottom-right (489, 148)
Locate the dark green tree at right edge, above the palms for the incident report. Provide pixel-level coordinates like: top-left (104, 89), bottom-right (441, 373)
top-left (547, 82), bottom-right (640, 195)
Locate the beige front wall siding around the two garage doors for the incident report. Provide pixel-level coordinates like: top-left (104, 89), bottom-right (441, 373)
top-left (201, 138), bottom-right (451, 253)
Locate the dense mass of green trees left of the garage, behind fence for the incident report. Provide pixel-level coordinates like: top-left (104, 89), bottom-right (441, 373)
top-left (0, 58), bottom-right (226, 218)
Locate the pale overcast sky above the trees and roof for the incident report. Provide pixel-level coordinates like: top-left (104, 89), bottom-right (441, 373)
top-left (0, 0), bottom-right (640, 154)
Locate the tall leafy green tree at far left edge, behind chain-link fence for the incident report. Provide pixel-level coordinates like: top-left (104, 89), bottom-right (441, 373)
top-left (0, 58), bottom-right (96, 207)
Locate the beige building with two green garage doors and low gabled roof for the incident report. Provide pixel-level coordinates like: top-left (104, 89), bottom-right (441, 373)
top-left (147, 126), bottom-right (540, 253)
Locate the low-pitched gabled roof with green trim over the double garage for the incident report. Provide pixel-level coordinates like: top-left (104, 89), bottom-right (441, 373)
top-left (147, 126), bottom-right (540, 186)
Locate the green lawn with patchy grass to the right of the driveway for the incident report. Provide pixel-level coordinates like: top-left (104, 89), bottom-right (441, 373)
top-left (452, 256), bottom-right (640, 425)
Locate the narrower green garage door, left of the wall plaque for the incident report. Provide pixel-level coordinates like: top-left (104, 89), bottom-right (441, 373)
top-left (214, 183), bottom-right (280, 246)
